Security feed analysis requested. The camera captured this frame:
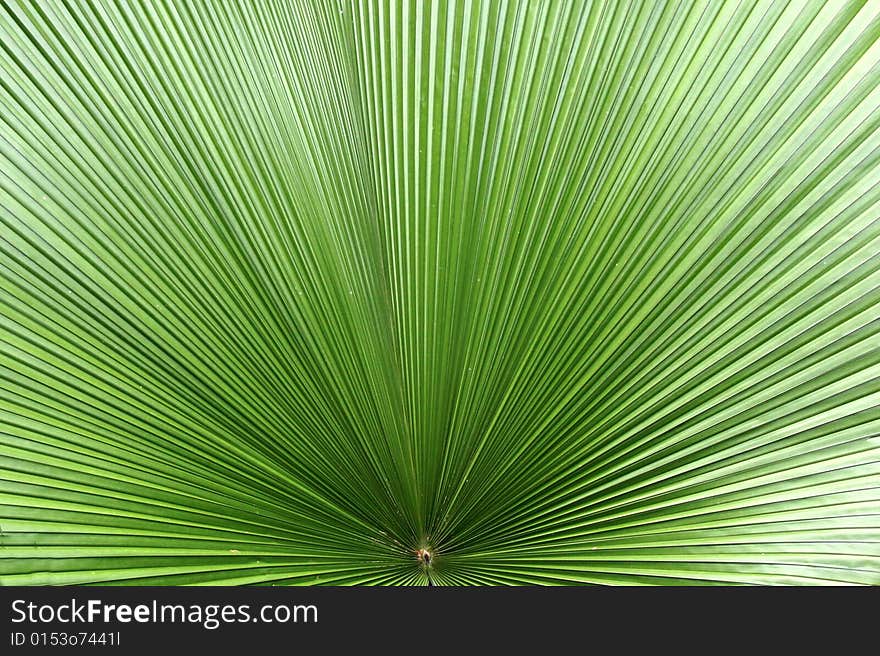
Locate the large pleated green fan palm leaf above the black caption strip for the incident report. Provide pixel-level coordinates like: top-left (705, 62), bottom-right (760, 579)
top-left (0, 0), bottom-right (880, 585)
